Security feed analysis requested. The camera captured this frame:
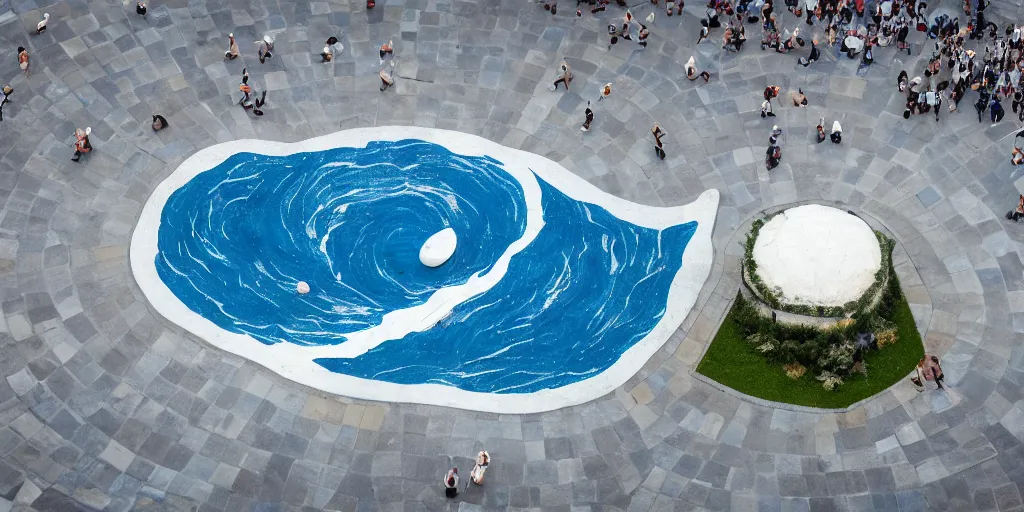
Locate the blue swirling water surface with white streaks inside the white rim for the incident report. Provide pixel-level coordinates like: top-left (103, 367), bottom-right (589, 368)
top-left (156, 140), bottom-right (696, 393)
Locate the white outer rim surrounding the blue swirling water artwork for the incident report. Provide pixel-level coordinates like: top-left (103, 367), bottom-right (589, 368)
top-left (129, 126), bottom-right (719, 414)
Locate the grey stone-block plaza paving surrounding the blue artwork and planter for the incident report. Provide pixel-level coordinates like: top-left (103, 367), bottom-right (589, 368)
top-left (0, 0), bottom-right (1024, 512)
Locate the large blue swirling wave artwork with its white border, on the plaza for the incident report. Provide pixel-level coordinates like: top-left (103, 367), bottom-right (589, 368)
top-left (131, 127), bottom-right (718, 414)
